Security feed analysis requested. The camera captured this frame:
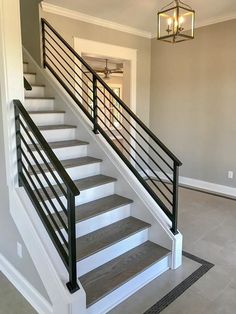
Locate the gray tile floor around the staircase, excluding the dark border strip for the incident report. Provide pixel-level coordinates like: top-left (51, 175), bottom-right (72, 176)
top-left (0, 188), bottom-right (236, 314)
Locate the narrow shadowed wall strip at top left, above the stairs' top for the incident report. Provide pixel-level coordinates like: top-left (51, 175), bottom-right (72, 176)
top-left (20, 0), bottom-right (41, 64)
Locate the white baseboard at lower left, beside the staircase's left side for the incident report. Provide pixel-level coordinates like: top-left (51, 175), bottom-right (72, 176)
top-left (0, 254), bottom-right (53, 314)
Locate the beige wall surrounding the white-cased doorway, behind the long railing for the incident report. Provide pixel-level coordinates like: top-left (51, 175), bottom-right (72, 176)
top-left (42, 12), bottom-right (151, 124)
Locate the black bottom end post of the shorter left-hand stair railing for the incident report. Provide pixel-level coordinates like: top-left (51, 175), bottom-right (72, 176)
top-left (67, 188), bottom-right (79, 293)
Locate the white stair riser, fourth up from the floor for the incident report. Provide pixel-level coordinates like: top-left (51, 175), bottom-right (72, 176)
top-left (42, 182), bottom-right (115, 212)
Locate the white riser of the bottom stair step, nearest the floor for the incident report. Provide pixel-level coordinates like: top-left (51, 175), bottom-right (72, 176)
top-left (86, 256), bottom-right (170, 314)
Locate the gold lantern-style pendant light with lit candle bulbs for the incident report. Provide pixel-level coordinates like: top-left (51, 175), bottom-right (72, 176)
top-left (157, 0), bottom-right (195, 43)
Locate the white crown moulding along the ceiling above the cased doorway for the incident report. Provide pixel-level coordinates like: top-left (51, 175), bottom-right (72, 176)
top-left (41, 2), bottom-right (151, 39)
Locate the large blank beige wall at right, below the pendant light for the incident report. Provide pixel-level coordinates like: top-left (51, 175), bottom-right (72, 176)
top-left (150, 20), bottom-right (236, 186)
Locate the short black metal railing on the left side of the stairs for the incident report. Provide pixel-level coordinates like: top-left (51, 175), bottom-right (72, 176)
top-left (13, 100), bottom-right (80, 293)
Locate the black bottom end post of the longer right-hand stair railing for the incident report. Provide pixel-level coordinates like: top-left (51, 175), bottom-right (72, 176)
top-left (171, 161), bottom-right (179, 235)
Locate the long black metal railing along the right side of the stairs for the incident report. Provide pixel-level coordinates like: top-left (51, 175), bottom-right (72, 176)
top-left (42, 19), bottom-right (182, 234)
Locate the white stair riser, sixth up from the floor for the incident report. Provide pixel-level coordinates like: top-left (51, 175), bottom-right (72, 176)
top-left (27, 145), bottom-right (88, 165)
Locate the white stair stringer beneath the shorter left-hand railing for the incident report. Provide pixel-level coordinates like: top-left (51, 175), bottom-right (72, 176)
top-left (10, 188), bottom-right (87, 314)
